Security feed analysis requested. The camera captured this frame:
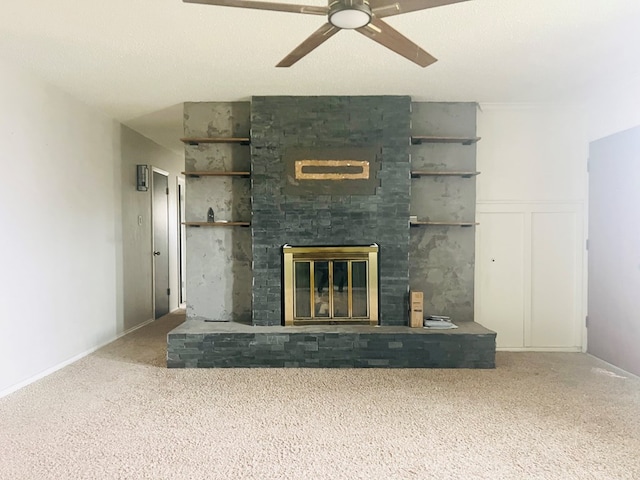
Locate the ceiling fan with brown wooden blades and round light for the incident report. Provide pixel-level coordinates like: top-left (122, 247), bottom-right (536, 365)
top-left (182, 0), bottom-right (469, 67)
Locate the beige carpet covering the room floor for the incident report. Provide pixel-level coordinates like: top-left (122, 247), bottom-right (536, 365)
top-left (0, 315), bottom-right (640, 480)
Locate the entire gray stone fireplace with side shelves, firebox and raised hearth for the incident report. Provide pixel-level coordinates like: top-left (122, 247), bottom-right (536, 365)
top-left (167, 96), bottom-right (495, 368)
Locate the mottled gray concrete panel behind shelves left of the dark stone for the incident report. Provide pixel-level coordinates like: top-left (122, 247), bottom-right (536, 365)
top-left (184, 102), bottom-right (251, 322)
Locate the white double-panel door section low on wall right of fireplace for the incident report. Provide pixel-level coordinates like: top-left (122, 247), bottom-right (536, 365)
top-left (475, 204), bottom-right (584, 351)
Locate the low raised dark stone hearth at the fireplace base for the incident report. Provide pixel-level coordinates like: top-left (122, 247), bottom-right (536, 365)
top-left (167, 321), bottom-right (496, 368)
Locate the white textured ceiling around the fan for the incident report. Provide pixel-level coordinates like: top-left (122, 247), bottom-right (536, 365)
top-left (0, 0), bottom-right (640, 154)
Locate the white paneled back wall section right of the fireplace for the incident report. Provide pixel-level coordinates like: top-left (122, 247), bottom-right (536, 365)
top-left (475, 105), bottom-right (588, 350)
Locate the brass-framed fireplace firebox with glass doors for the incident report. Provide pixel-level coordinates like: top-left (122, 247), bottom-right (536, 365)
top-left (282, 244), bottom-right (379, 325)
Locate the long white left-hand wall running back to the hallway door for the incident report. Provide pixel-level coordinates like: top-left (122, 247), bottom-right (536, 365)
top-left (0, 62), bottom-right (182, 397)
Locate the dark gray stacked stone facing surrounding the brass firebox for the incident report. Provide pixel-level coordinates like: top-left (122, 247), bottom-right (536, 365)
top-left (251, 96), bottom-right (410, 325)
